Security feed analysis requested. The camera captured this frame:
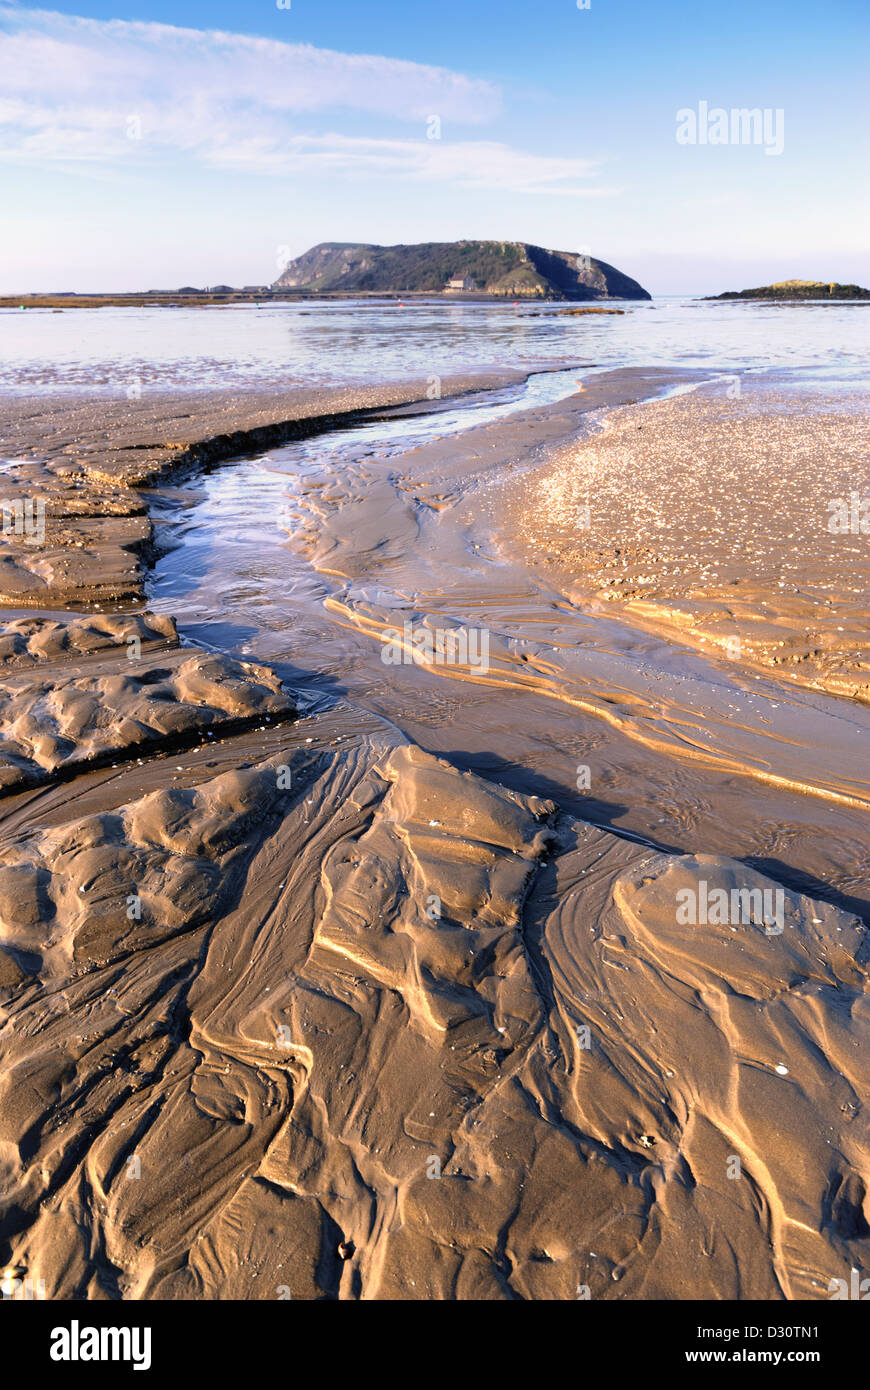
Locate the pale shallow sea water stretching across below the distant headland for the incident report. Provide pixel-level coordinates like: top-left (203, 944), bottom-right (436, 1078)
top-left (0, 297), bottom-right (870, 393)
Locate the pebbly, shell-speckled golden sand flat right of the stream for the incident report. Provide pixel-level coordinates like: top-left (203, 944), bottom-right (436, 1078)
top-left (499, 377), bottom-right (870, 701)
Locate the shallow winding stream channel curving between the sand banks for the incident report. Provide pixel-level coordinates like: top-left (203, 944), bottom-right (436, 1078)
top-left (150, 370), bottom-right (870, 915)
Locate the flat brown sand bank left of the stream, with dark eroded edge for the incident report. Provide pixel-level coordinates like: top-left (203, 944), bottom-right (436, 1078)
top-left (0, 371), bottom-right (524, 607)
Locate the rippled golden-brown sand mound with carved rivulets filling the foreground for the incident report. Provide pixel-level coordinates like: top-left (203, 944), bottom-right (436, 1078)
top-left (0, 717), bottom-right (869, 1300)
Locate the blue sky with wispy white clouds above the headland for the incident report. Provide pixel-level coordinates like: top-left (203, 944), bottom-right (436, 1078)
top-left (0, 0), bottom-right (870, 293)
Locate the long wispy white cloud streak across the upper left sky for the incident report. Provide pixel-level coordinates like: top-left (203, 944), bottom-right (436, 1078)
top-left (0, 6), bottom-right (606, 196)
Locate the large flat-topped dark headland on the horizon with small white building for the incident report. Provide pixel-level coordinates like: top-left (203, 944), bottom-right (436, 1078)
top-left (272, 242), bottom-right (652, 299)
